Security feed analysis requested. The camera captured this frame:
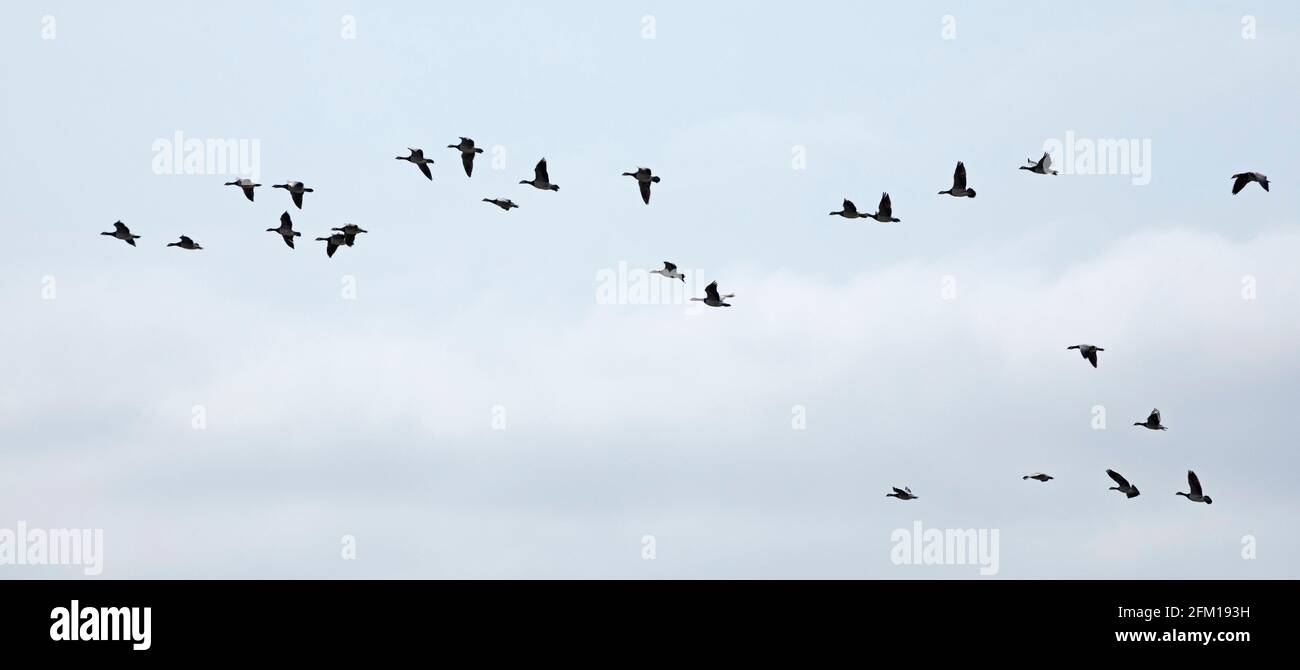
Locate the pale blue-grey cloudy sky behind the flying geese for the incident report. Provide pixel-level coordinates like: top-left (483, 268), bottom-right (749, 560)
top-left (0, 1), bottom-right (1300, 579)
